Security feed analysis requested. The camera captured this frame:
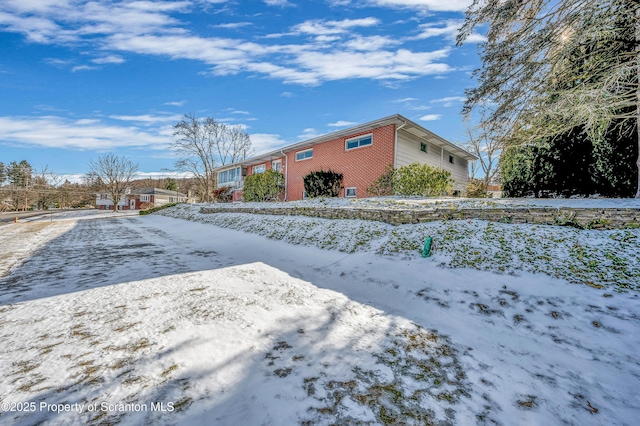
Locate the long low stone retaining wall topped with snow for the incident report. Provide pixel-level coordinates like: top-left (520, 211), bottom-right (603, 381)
top-left (200, 207), bottom-right (640, 229)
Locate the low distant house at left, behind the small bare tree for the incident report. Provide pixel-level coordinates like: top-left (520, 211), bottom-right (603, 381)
top-left (96, 188), bottom-right (188, 210)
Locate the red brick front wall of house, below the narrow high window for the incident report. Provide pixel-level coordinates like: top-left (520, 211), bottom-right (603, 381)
top-left (287, 124), bottom-right (395, 201)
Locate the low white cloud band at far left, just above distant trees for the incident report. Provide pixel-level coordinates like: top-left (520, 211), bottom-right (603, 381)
top-left (0, 116), bottom-right (171, 150)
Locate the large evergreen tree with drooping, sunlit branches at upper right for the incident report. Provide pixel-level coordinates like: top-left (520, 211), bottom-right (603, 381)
top-left (458, 0), bottom-right (640, 197)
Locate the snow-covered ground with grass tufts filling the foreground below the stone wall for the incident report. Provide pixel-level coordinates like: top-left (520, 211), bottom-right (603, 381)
top-left (0, 206), bottom-right (640, 425)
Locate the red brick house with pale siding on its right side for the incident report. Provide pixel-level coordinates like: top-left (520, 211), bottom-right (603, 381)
top-left (217, 114), bottom-right (476, 201)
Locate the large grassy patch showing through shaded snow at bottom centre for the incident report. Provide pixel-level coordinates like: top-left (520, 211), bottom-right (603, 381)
top-left (304, 325), bottom-right (470, 425)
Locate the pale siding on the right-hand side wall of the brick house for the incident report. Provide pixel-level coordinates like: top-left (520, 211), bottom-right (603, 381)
top-left (396, 131), bottom-right (469, 195)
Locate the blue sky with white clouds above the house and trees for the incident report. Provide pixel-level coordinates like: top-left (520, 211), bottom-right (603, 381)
top-left (0, 0), bottom-right (482, 181)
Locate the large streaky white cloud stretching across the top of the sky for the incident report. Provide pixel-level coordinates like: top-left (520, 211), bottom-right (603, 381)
top-left (0, 0), bottom-right (460, 85)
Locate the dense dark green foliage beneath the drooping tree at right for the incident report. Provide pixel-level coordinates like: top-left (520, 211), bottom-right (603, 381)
top-left (500, 122), bottom-right (637, 197)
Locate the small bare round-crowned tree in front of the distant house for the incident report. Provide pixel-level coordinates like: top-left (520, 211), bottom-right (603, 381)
top-left (86, 154), bottom-right (138, 213)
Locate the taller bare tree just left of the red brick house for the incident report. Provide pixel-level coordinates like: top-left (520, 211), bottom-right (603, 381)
top-left (173, 114), bottom-right (252, 202)
